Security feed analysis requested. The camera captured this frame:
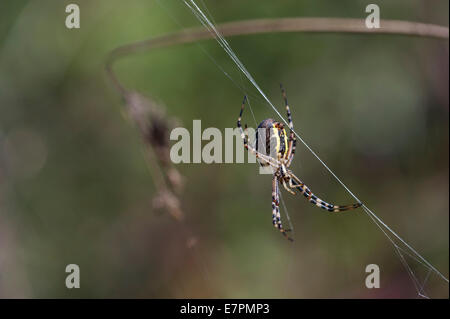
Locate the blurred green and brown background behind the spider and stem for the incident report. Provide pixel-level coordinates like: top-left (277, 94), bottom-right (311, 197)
top-left (0, 0), bottom-right (449, 298)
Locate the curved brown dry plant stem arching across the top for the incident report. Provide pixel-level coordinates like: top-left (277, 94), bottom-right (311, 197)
top-left (106, 18), bottom-right (449, 95)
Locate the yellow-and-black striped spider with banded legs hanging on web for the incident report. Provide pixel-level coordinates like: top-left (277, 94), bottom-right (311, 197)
top-left (237, 85), bottom-right (362, 241)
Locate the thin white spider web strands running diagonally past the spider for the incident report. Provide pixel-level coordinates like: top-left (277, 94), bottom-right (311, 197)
top-left (157, 0), bottom-right (449, 298)
